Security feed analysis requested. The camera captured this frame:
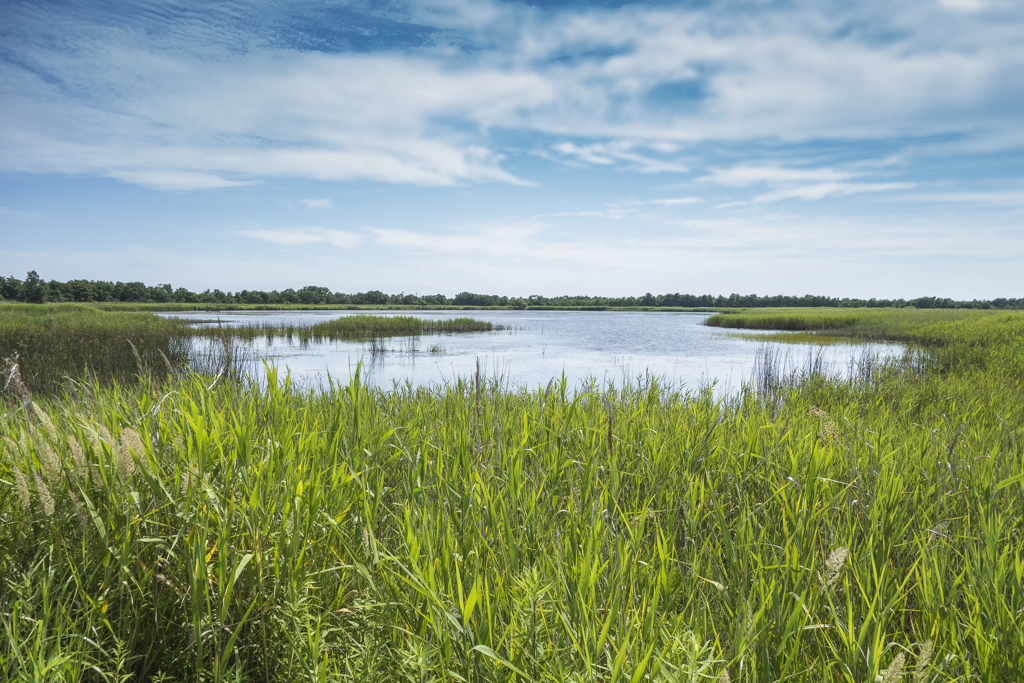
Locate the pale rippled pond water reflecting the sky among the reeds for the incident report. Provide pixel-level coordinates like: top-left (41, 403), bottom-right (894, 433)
top-left (162, 310), bottom-right (903, 394)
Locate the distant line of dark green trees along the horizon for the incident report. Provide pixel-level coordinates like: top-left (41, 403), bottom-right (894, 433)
top-left (0, 270), bottom-right (1024, 309)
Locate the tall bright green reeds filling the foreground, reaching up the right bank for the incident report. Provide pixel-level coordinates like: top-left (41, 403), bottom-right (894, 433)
top-left (0, 311), bottom-right (1024, 683)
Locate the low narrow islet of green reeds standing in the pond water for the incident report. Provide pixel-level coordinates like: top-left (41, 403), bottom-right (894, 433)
top-left (196, 315), bottom-right (505, 343)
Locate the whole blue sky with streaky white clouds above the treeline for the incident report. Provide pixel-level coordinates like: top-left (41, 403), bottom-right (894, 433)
top-left (0, 0), bottom-right (1024, 299)
